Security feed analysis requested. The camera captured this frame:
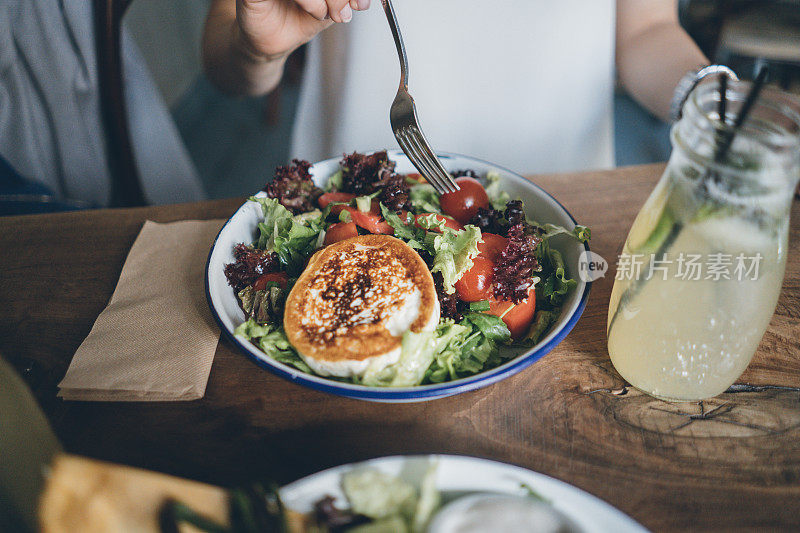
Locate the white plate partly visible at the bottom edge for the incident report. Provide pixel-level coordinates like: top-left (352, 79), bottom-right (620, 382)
top-left (280, 455), bottom-right (647, 533)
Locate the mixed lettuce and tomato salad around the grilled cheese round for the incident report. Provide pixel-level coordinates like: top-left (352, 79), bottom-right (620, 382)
top-left (225, 151), bottom-right (590, 386)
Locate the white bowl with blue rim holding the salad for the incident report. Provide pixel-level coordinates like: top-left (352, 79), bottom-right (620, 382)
top-left (205, 150), bottom-right (591, 402)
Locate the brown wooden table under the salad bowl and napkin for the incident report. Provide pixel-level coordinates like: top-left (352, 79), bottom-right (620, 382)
top-left (0, 165), bottom-right (800, 531)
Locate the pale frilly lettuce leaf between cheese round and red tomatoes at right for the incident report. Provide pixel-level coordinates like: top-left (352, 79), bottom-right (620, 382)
top-left (432, 224), bottom-right (481, 294)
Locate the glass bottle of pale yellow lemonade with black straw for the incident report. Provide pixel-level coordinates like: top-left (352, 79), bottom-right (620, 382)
top-left (607, 80), bottom-right (800, 401)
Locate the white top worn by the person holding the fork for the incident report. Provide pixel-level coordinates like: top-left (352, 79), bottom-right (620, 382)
top-left (292, 0), bottom-right (616, 173)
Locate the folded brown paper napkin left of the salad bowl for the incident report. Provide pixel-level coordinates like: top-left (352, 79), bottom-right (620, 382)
top-left (59, 220), bottom-right (224, 401)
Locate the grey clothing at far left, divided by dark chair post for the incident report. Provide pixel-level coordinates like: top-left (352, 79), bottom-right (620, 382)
top-left (0, 0), bottom-right (204, 209)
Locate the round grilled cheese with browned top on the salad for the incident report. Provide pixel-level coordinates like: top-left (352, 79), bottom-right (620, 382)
top-left (283, 235), bottom-right (439, 377)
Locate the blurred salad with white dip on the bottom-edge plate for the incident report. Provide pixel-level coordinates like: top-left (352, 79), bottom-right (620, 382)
top-left (161, 461), bottom-right (581, 533)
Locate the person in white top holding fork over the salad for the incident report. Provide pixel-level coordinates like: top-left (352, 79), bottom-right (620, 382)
top-left (203, 0), bottom-right (708, 172)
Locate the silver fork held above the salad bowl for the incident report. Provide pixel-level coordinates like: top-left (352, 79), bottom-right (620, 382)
top-left (381, 0), bottom-right (459, 194)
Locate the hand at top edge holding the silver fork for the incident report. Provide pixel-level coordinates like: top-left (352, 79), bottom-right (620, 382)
top-left (236, 0), bottom-right (370, 60)
